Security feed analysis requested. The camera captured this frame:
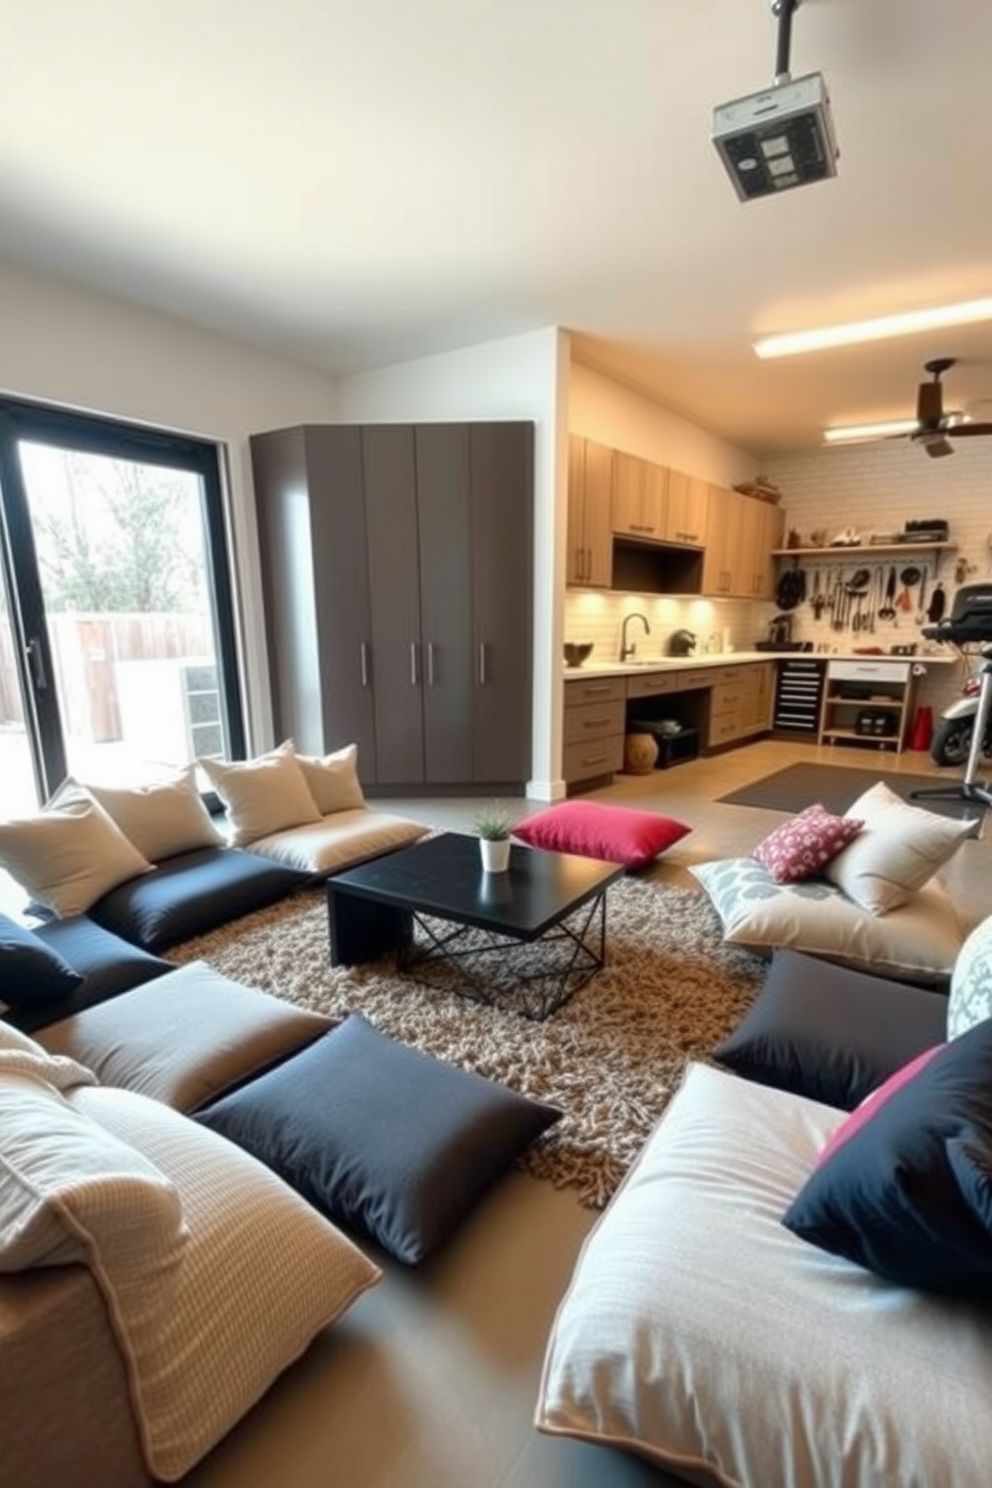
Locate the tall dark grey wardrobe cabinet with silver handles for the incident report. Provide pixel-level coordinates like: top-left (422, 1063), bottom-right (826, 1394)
top-left (250, 423), bottom-right (534, 793)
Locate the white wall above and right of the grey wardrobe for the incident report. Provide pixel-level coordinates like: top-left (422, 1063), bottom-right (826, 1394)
top-left (338, 326), bottom-right (568, 801)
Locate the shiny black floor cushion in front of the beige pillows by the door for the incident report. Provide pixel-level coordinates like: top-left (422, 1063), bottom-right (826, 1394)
top-left (89, 847), bottom-right (306, 951)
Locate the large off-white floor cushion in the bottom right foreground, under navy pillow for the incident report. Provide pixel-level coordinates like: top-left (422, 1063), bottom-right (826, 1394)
top-left (537, 1064), bottom-right (992, 1488)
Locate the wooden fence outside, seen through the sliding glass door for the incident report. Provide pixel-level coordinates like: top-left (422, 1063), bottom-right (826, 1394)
top-left (0, 615), bottom-right (214, 744)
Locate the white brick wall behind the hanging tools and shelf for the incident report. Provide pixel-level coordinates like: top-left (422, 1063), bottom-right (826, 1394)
top-left (766, 439), bottom-right (992, 714)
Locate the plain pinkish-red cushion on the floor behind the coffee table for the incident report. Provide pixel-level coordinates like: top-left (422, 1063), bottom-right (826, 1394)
top-left (513, 801), bottom-right (692, 868)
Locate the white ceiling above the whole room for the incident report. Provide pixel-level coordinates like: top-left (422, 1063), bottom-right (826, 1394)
top-left (0, 0), bottom-right (992, 452)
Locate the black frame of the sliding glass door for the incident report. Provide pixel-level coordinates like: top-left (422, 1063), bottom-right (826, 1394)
top-left (0, 396), bottom-right (245, 801)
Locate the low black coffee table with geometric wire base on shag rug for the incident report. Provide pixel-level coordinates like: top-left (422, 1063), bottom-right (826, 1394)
top-left (327, 832), bottom-right (623, 1019)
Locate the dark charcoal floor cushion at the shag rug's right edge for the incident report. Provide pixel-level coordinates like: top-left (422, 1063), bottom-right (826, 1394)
top-left (714, 951), bottom-right (947, 1110)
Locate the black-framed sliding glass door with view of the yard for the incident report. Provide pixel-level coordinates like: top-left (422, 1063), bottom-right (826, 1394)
top-left (0, 399), bottom-right (244, 815)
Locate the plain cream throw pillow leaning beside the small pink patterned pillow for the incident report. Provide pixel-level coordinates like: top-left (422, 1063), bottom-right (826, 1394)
top-left (824, 780), bottom-right (974, 915)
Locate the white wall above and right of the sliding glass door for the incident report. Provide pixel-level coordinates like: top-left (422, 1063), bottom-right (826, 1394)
top-left (0, 259), bottom-right (338, 745)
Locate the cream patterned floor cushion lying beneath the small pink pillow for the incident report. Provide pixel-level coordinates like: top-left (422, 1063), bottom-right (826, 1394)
top-left (689, 848), bottom-right (964, 985)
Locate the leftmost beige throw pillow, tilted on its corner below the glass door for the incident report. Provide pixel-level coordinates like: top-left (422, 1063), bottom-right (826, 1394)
top-left (0, 783), bottom-right (152, 918)
